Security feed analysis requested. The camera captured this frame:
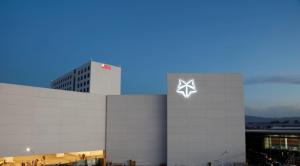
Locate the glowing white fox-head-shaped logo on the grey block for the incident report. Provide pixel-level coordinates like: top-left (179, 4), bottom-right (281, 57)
top-left (176, 79), bottom-right (197, 98)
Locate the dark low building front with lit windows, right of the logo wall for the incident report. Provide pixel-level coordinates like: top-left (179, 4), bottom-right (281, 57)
top-left (246, 130), bottom-right (300, 165)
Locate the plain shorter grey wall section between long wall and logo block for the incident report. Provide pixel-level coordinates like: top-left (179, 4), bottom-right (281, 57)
top-left (106, 95), bottom-right (167, 166)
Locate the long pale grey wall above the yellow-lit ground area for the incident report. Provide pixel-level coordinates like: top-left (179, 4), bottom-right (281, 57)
top-left (0, 83), bottom-right (106, 156)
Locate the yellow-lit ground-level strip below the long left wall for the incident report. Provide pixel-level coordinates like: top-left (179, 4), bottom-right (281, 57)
top-left (0, 149), bottom-right (104, 166)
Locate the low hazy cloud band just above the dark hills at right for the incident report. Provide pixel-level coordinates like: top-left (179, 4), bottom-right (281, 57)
top-left (245, 106), bottom-right (300, 118)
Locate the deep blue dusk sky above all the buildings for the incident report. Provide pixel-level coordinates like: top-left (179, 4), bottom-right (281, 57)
top-left (0, 0), bottom-right (300, 117)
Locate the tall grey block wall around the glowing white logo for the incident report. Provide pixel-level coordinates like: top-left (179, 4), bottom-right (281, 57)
top-left (167, 74), bottom-right (245, 166)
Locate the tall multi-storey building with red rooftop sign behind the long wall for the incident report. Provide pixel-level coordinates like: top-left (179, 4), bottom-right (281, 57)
top-left (51, 61), bottom-right (121, 94)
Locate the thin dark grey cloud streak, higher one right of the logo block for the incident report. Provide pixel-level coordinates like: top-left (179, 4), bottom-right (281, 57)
top-left (245, 75), bottom-right (300, 85)
